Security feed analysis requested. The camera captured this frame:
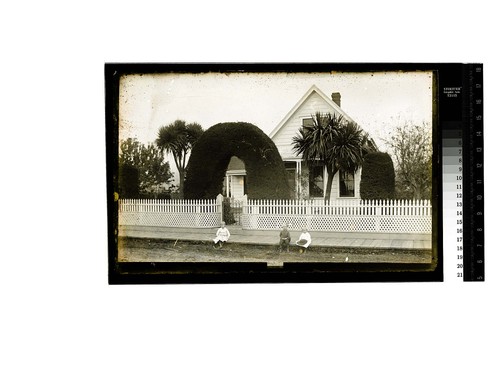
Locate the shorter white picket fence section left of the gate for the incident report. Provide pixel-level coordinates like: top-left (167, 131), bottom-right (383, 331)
top-left (118, 196), bottom-right (222, 228)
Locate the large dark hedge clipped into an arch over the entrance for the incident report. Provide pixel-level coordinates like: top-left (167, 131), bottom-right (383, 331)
top-left (184, 122), bottom-right (290, 199)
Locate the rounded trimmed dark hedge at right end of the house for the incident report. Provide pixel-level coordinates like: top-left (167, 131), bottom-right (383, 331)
top-left (360, 152), bottom-right (396, 199)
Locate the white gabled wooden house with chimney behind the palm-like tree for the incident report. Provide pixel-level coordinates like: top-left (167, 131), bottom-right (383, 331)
top-left (225, 85), bottom-right (370, 200)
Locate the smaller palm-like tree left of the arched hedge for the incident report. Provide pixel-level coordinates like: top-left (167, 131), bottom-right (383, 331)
top-left (156, 120), bottom-right (203, 199)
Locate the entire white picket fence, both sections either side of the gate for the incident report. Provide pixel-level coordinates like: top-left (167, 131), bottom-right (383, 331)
top-left (118, 195), bottom-right (432, 233)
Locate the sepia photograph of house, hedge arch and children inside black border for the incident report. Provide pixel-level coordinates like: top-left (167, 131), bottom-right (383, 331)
top-left (110, 65), bottom-right (438, 282)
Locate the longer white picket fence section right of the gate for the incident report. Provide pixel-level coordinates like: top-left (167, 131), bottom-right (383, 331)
top-left (241, 198), bottom-right (432, 233)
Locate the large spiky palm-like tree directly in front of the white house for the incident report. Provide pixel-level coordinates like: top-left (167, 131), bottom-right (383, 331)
top-left (292, 112), bottom-right (377, 202)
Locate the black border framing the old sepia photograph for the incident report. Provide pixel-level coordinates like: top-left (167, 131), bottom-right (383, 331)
top-left (104, 63), bottom-right (465, 284)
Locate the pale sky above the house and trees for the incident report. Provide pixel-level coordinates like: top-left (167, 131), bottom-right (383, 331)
top-left (119, 72), bottom-right (432, 151)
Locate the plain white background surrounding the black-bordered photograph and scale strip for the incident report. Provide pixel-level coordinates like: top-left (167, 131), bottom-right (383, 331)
top-left (0, 1), bottom-right (500, 375)
